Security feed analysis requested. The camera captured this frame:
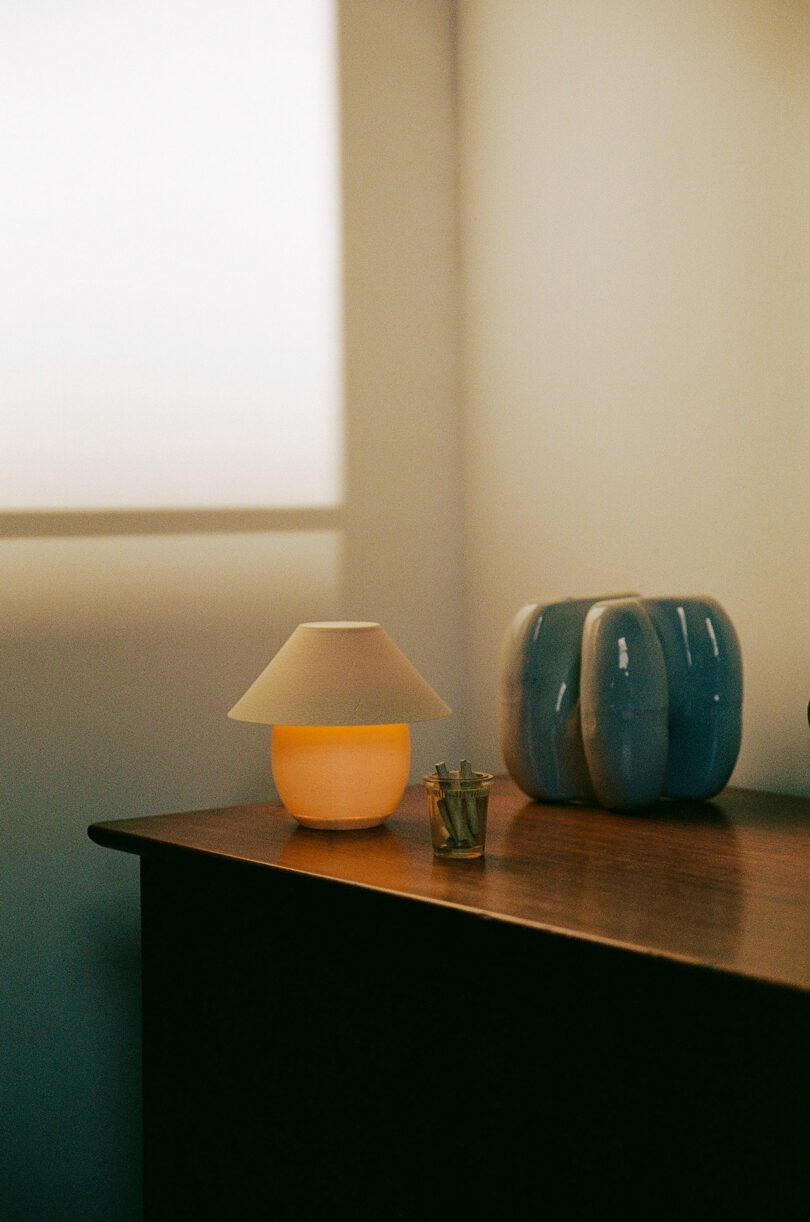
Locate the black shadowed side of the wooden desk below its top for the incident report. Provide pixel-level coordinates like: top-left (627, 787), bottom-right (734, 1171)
top-left (142, 855), bottom-right (810, 1222)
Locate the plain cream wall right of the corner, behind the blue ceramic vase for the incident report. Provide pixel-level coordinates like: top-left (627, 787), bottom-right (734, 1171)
top-left (458, 0), bottom-right (810, 793)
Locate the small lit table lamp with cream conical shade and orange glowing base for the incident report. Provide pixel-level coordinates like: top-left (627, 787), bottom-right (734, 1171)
top-left (228, 622), bottom-right (452, 829)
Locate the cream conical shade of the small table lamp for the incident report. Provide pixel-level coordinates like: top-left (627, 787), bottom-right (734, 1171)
top-left (228, 622), bottom-right (452, 726)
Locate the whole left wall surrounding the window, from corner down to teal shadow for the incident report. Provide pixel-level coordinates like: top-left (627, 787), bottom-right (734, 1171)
top-left (0, 0), bottom-right (463, 1222)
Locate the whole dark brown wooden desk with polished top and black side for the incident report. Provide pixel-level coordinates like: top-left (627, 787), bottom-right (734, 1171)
top-left (90, 780), bottom-right (810, 1222)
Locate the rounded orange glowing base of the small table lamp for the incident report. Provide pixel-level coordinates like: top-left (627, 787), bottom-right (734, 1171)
top-left (270, 725), bottom-right (410, 830)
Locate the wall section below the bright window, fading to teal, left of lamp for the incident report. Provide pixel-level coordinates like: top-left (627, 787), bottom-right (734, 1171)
top-left (0, 529), bottom-right (341, 1222)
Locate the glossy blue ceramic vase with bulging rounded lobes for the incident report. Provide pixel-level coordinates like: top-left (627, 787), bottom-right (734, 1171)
top-left (500, 595), bottom-right (743, 810)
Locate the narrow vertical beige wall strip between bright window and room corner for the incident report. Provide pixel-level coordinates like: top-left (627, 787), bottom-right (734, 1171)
top-left (340, 0), bottom-right (467, 780)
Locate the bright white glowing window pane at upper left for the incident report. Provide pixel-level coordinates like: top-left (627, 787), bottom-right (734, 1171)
top-left (0, 0), bottom-right (342, 510)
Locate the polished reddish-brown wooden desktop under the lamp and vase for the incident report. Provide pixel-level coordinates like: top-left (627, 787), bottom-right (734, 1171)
top-left (89, 778), bottom-right (810, 990)
